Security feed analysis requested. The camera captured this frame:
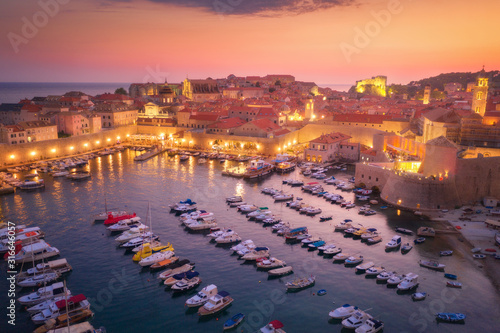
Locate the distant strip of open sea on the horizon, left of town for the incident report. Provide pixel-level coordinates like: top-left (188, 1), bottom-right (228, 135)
top-left (0, 82), bottom-right (130, 103)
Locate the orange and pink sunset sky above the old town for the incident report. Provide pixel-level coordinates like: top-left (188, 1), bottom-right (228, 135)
top-left (0, 0), bottom-right (500, 84)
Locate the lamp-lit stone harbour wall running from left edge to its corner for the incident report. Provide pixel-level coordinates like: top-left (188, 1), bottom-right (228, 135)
top-left (0, 125), bottom-right (137, 166)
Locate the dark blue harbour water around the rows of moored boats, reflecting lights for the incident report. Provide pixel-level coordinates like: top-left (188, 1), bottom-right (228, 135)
top-left (0, 150), bottom-right (500, 332)
